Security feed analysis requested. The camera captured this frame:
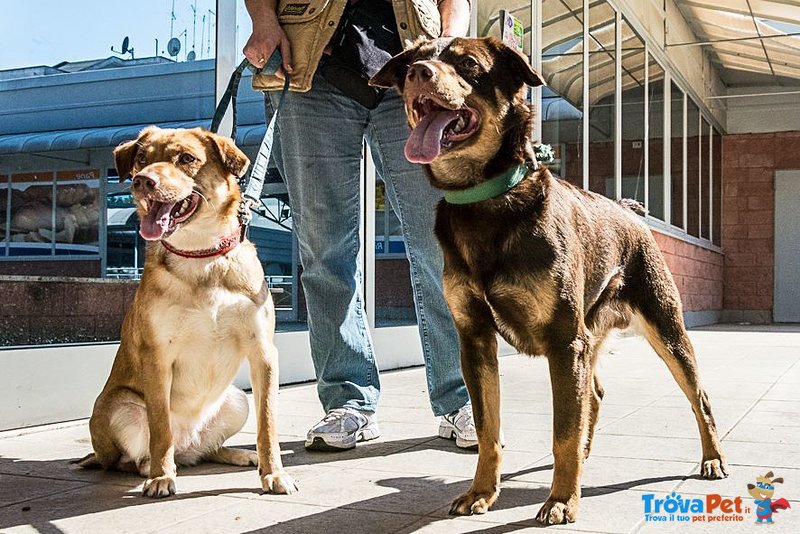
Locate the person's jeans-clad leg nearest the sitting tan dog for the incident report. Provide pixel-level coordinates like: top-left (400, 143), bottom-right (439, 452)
top-left (268, 76), bottom-right (380, 418)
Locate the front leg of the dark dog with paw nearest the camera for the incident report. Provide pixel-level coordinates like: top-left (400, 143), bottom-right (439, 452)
top-left (536, 333), bottom-right (599, 525)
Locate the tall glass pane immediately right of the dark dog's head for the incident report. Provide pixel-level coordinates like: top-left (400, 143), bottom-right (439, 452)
top-left (540, 0), bottom-right (583, 186)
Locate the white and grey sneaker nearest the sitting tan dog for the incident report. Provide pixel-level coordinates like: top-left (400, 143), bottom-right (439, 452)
top-left (306, 408), bottom-right (381, 451)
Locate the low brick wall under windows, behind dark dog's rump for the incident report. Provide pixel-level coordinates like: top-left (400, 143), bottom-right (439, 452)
top-left (653, 230), bottom-right (724, 312)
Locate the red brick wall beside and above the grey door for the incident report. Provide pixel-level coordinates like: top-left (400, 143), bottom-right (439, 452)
top-left (722, 131), bottom-right (800, 322)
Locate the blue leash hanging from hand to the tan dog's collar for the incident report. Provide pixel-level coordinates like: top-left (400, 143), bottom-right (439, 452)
top-left (209, 49), bottom-right (290, 237)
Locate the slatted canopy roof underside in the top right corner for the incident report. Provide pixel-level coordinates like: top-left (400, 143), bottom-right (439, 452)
top-left (667, 0), bottom-right (800, 86)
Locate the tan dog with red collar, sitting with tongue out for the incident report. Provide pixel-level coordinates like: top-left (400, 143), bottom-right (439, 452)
top-left (81, 127), bottom-right (297, 497)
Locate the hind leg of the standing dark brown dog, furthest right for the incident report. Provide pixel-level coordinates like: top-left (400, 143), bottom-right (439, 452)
top-left (634, 251), bottom-right (728, 479)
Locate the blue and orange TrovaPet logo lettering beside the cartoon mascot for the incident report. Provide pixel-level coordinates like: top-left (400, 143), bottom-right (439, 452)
top-left (642, 491), bottom-right (750, 523)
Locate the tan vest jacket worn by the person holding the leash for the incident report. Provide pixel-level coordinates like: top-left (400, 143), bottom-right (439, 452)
top-left (253, 0), bottom-right (442, 92)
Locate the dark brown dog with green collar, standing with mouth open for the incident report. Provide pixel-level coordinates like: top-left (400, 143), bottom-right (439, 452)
top-left (372, 39), bottom-right (727, 524)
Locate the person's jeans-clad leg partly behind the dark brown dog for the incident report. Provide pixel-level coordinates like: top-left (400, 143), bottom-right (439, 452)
top-left (366, 93), bottom-right (471, 423)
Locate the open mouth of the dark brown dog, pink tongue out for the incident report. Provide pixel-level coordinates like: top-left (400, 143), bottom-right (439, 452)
top-left (405, 96), bottom-right (480, 163)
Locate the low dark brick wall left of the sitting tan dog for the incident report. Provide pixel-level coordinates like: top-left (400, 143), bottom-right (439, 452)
top-left (0, 277), bottom-right (136, 346)
